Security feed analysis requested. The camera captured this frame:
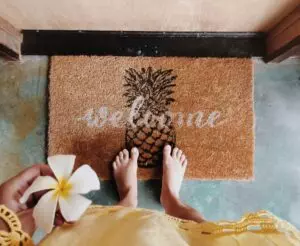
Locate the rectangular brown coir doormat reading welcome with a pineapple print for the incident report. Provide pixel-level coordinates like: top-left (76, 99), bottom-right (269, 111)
top-left (48, 56), bottom-right (254, 180)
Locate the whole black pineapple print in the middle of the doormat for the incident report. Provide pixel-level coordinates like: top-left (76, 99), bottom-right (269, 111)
top-left (124, 67), bottom-right (177, 167)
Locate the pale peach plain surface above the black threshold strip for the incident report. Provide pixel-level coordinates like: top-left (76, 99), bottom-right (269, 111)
top-left (0, 0), bottom-right (299, 31)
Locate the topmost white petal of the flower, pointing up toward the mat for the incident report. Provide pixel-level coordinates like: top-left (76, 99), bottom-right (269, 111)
top-left (48, 155), bottom-right (76, 180)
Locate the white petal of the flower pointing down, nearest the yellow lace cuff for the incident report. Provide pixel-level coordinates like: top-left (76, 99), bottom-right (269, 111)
top-left (33, 190), bottom-right (58, 233)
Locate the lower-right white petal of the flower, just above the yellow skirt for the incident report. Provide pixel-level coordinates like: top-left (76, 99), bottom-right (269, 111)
top-left (58, 194), bottom-right (92, 221)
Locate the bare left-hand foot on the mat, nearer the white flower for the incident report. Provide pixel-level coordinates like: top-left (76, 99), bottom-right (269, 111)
top-left (113, 148), bottom-right (139, 207)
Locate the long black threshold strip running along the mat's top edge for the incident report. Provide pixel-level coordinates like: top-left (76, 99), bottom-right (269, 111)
top-left (21, 30), bottom-right (265, 58)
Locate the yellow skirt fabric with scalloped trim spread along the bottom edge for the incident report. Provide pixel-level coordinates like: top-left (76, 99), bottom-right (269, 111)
top-left (40, 206), bottom-right (300, 246)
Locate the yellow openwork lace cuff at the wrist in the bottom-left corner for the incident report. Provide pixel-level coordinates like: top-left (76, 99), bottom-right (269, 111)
top-left (0, 205), bottom-right (34, 246)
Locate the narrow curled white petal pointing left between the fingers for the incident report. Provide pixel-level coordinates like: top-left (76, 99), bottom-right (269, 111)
top-left (20, 176), bottom-right (57, 203)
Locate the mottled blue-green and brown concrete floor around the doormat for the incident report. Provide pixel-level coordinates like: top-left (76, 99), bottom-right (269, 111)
top-left (0, 57), bottom-right (300, 231)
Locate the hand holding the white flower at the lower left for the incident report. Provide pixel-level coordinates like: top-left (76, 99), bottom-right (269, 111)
top-left (0, 165), bottom-right (56, 235)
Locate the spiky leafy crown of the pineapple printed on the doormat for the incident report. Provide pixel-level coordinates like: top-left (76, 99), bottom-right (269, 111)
top-left (124, 67), bottom-right (177, 115)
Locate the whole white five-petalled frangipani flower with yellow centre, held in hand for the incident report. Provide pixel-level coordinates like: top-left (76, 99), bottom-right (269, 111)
top-left (20, 155), bottom-right (100, 233)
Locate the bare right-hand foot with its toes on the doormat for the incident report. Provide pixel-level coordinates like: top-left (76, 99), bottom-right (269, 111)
top-left (160, 145), bottom-right (187, 208)
